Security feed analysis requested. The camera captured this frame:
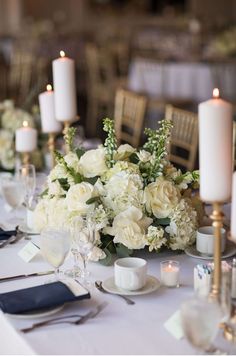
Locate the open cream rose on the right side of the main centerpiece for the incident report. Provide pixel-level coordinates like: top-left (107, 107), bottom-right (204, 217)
top-left (144, 176), bottom-right (180, 219)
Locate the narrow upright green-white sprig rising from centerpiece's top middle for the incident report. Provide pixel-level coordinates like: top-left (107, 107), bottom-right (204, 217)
top-left (103, 118), bottom-right (117, 168)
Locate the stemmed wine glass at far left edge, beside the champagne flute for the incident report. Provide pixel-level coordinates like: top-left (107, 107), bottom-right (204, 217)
top-left (1, 176), bottom-right (24, 225)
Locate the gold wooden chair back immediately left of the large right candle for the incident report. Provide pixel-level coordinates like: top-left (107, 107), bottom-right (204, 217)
top-left (165, 105), bottom-right (198, 171)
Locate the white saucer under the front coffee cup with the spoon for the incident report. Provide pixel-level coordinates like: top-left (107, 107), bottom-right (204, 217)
top-left (102, 276), bottom-right (161, 295)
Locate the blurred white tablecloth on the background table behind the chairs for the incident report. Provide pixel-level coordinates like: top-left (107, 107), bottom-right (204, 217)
top-left (128, 58), bottom-right (236, 103)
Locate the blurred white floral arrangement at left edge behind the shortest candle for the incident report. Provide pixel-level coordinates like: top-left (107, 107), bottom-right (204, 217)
top-left (0, 100), bottom-right (42, 171)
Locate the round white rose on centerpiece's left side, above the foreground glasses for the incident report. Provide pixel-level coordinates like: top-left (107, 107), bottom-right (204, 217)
top-left (65, 182), bottom-right (95, 214)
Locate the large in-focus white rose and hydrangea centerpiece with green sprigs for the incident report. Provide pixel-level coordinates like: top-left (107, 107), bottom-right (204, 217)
top-left (34, 118), bottom-right (201, 260)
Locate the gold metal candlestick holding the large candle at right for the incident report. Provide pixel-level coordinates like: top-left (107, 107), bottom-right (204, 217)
top-left (210, 202), bottom-right (224, 301)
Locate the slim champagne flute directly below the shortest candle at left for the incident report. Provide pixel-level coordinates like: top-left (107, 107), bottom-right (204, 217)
top-left (17, 164), bottom-right (36, 209)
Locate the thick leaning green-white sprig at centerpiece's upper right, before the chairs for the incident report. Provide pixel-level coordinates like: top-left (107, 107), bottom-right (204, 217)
top-left (143, 119), bottom-right (173, 182)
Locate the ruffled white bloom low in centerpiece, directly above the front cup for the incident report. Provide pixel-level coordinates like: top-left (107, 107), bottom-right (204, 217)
top-left (106, 207), bottom-right (152, 249)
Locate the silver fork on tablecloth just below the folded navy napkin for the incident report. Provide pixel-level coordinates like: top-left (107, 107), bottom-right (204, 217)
top-left (20, 302), bottom-right (108, 333)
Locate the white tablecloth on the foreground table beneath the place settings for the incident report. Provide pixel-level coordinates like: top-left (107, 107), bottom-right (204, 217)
top-left (0, 202), bottom-right (236, 355)
